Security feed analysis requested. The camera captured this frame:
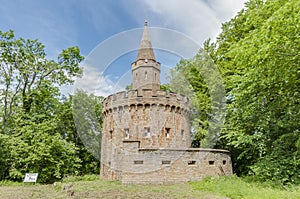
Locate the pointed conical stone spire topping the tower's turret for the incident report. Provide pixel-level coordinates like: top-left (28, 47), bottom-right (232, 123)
top-left (136, 21), bottom-right (155, 61)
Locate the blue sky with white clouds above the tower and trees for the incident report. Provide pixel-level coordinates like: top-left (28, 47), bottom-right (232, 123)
top-left (0, 0), bottom-right (245, 96)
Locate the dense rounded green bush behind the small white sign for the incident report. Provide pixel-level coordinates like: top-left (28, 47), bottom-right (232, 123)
top-left (7, 116), bottom-right (80, 182)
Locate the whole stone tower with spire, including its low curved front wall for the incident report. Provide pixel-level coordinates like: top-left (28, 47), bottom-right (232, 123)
top-left (100, 22), bottom-right (232, 183)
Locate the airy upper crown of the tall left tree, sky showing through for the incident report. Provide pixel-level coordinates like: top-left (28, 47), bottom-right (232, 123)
top-left (0, 31), bottom-right (83, 131)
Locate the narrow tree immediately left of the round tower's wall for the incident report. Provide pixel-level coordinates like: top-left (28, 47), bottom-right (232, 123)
top-left (72, 90), bottom-right (103, 173)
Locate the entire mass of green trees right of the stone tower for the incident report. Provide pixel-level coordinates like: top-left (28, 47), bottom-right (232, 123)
top-left (170, 0), bottom-right (300, 184)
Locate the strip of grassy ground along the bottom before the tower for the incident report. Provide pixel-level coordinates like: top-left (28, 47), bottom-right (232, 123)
top-left (0, 175), bottom-right (300, 199)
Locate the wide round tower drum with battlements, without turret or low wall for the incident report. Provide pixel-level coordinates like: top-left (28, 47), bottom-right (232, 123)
top-left (101, 90), bottom-right (191, 179)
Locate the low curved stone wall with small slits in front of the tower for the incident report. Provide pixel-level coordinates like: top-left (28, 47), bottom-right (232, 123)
top-left (120, 148), bottom-right (232, 184)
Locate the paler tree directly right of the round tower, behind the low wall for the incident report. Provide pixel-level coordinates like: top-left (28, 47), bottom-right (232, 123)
top-left (170, 48), bottom-right (225, 147)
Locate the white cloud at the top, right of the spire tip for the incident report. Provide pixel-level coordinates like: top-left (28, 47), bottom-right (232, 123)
top-left (123, 0), bottom-right (246, 44)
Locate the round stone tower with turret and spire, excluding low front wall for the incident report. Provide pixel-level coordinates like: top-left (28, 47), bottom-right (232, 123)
top-left (101, 22), bottom-right (191, 180)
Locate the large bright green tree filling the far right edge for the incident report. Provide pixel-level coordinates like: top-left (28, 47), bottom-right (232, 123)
top-left (212, 0), bottom-right (300, 183)
